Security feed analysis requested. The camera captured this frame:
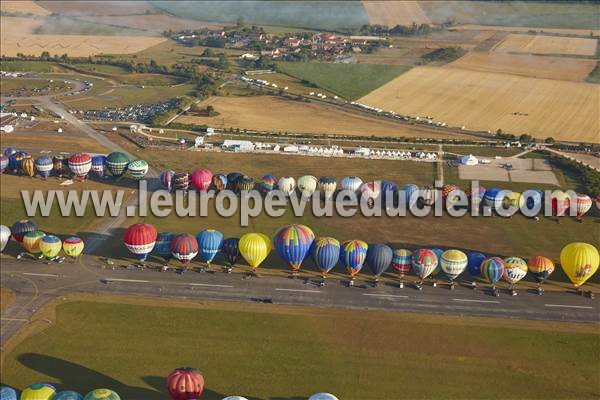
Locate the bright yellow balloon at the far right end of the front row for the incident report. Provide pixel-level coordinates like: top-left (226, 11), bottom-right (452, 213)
top-left (560, 242), bottom-right (600, 288)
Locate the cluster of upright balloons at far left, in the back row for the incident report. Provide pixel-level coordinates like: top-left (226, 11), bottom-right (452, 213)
top-left (0, 147), bottom-right (148, 180)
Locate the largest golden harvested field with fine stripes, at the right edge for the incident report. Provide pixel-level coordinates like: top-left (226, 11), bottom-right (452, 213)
top-left (358, 67), bottom-right (600, 143)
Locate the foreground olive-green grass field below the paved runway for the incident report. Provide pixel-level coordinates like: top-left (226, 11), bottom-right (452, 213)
top-left (2, 297), bottom-right (600, 400)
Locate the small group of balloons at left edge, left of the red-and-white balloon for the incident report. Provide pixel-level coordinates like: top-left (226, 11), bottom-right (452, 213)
top-left (0, 219), bottom-right (85, 260)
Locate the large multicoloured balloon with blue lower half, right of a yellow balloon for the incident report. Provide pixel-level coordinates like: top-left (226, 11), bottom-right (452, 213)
top-left (273, 225), bottom-right (316, 275)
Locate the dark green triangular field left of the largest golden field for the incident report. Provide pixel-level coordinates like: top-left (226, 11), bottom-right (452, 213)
top-left (277, 62), bottom-right (410, 100)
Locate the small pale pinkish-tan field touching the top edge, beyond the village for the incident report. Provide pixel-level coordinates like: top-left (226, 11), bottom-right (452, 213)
top-left (362, 1), bottom-right (431, 27)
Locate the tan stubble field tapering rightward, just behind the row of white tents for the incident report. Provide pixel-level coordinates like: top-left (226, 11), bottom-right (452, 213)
top-left (175, 96), bottom-right (472, 138)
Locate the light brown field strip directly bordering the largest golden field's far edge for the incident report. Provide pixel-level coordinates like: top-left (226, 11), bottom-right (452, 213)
top-left (446, 52), bottom-right (596, 82)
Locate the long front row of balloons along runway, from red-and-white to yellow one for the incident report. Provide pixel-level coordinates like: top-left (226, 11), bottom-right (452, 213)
top-left (123, 223), bottom-right (599, 287)
